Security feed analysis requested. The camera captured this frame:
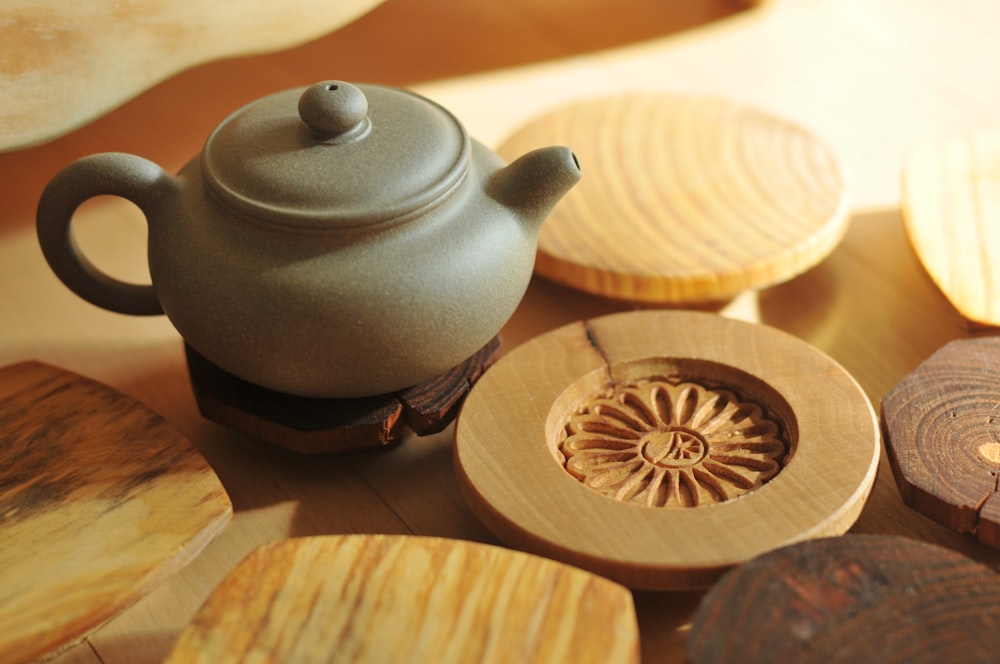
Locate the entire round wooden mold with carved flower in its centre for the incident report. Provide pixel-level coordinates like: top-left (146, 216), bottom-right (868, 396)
top-left (455, 311), bottom-right (879, 589)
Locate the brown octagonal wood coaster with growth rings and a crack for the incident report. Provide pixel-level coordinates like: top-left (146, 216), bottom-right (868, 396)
top-left (882, 337), bottom-right (1000, 548)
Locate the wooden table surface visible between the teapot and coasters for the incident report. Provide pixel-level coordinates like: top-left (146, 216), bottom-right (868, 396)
top-left (0, 0), bottom-right (1000, 663)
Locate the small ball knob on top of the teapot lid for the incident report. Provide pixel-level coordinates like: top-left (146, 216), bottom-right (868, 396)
top-left (299, 81), bottom-right (369, 140)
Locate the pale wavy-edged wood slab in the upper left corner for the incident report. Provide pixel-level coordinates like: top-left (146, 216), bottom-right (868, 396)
top-left (0, 0), bottom-right (382, 151)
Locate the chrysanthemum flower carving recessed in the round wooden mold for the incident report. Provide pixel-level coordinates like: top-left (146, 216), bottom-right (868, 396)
top-left (559, 379), bottom-right (789, 507)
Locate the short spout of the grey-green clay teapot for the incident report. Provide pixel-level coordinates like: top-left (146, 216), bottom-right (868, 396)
top-left (488, 146), bottom-right (581, 230)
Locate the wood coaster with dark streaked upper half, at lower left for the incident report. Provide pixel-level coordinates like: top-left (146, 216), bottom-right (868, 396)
top-left (0, 363), bottom-right (232, 662)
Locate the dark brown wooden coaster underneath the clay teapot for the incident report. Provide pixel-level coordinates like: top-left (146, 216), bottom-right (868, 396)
top-left (185, 337), bottom-right (501, 454)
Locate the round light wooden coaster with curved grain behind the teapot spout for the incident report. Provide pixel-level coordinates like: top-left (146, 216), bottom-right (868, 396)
top-left (499, 94), bottom-right (848, 304)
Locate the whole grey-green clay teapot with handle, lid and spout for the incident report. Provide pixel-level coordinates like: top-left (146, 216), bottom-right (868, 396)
top-left (37, 81), bottom-right (580, 398)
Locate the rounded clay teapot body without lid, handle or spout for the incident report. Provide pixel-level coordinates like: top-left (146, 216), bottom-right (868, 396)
top-left (149, 144), bottom-right (536, 398)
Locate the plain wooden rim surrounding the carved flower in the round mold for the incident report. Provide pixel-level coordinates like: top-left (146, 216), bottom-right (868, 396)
top-left (455, 311), bottom-right (879, 590)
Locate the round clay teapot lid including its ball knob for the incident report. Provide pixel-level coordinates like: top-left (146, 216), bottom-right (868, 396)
top-left (201, 81), bottom-right (470, 229)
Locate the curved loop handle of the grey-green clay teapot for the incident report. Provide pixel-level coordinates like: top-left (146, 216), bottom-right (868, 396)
top-left (36, 152), bottom-right (177, 316)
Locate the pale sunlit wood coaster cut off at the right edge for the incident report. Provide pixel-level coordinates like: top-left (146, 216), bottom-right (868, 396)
top-left (903, 132), bottom-right (1000, 327)
